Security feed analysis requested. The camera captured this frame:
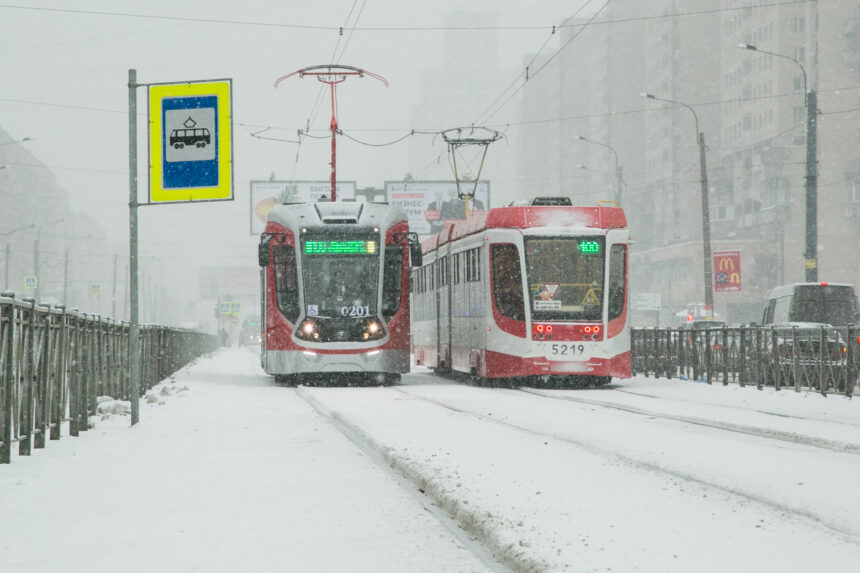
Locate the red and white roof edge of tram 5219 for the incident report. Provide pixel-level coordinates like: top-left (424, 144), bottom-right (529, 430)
top-left (421, 206), bottom-right (627, 253)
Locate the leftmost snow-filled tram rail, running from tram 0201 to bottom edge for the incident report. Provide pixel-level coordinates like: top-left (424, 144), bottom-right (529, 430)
top-left (294, 386), bottom-right (524, 573)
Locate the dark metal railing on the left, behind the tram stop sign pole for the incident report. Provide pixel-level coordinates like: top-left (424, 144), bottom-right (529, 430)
top-left (0, 292), bottom-right (218, 463)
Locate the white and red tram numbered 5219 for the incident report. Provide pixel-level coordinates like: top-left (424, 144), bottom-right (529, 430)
top-left (412, 200), bottom-right (631, 385)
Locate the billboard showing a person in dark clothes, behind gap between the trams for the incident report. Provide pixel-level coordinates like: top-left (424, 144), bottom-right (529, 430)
top-left (385, 181), bottom-right (490, 237)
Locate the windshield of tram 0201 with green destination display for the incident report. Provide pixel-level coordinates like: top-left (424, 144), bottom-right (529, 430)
top-left (302, 235), bottom-right (379, 318)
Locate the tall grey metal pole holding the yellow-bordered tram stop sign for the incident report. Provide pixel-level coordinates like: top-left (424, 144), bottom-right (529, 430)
top-left (128, 69), bottom-right (140, 426)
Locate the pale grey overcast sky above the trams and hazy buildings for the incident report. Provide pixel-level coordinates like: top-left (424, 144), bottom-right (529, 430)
top-left (0, 0), bottom-right (605, 322)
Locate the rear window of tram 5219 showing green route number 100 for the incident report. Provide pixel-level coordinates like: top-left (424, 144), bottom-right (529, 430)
top-left (525, 237), bottom-right (606, 321)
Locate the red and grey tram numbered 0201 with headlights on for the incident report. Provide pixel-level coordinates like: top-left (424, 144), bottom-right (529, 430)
top-left (259, 202), bottom-right (421, 384)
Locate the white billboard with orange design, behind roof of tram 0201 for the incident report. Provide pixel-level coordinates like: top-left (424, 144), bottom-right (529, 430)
top-left (251, 181), bottom-right (356, 235)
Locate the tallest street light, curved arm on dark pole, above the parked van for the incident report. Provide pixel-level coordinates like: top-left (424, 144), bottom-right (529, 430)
top-left (738, 44), bottom-right (818, 282)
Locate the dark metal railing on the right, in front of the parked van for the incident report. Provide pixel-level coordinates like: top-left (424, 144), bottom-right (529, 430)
top-left (631, 326), bottom-right (860, 396)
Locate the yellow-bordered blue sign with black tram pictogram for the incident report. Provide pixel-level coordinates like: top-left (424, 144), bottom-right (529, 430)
top-left (148, 80), bottom-right (233, 203)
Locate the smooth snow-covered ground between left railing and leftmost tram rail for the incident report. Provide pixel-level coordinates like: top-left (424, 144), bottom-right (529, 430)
top-left (0, 349), bottom-right (494, 573)
